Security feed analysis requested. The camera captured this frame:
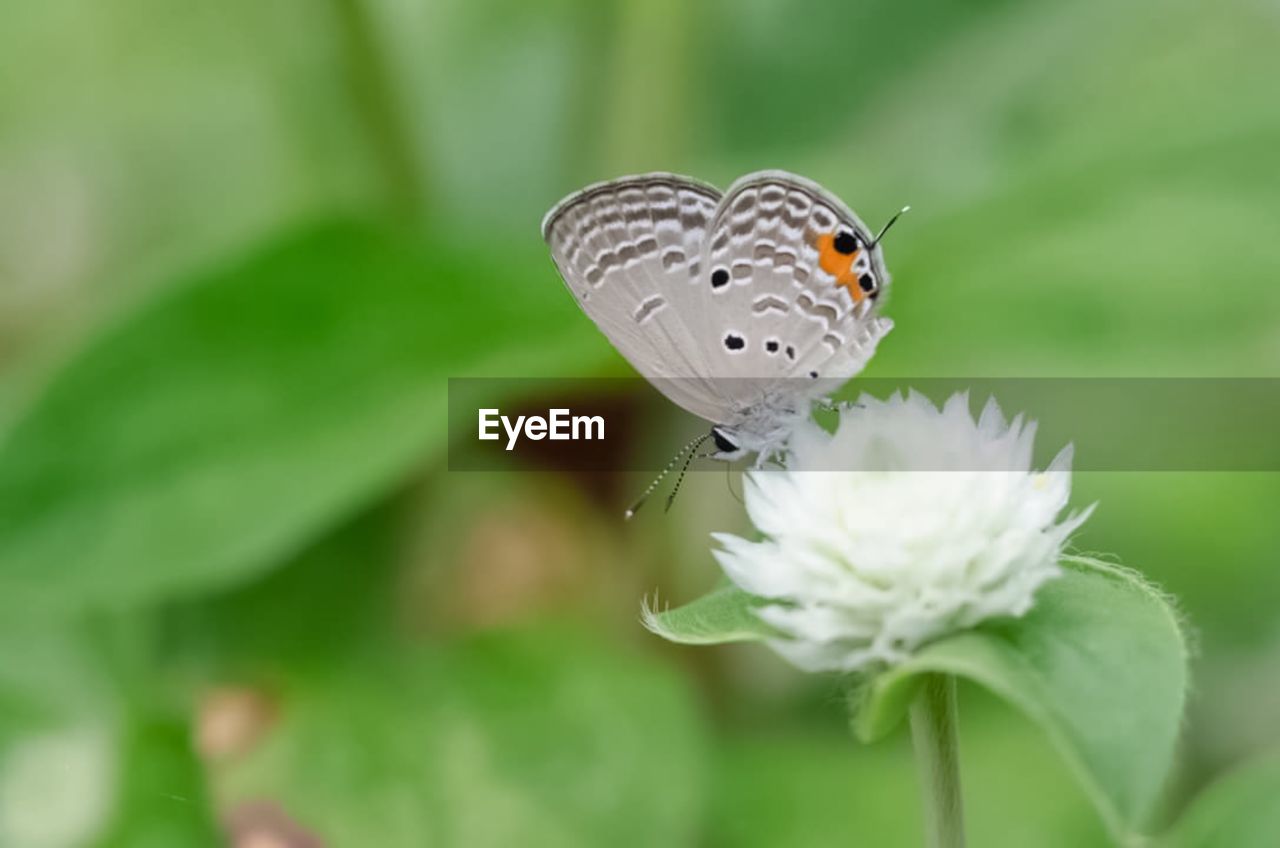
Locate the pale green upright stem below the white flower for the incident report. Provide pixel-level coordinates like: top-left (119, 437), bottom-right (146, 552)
top-left (911, 674), bottom-right (964, 848)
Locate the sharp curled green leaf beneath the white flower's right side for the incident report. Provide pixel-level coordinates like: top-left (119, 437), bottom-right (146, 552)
top-left (854, 557), bottom-right (1187, 838)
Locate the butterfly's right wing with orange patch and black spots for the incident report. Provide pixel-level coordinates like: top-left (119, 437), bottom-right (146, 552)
top-left (700, 170), bottom-right (893, 391)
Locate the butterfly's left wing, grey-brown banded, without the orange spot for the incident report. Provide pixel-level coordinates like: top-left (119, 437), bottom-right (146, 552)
top-left (543, 173), bottom-right (726, 423)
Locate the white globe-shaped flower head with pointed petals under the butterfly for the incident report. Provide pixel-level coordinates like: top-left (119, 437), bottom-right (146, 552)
top-left (716, 392), bottom-right (1092, 671)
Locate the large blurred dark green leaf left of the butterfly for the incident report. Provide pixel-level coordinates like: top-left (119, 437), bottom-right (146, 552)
top-left (0, 224), bottom-right (607, 614)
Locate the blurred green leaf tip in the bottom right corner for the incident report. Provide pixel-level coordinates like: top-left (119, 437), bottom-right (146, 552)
top-left (1169, 754), bottom-right (1280, 848)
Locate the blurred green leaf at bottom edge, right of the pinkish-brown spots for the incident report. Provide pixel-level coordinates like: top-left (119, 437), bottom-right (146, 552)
top-left (218, 630), bottom-right (704, 848)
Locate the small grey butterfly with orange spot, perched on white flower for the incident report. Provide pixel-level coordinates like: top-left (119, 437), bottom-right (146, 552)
top-left (541, 170), bottom-right (906, 507)
